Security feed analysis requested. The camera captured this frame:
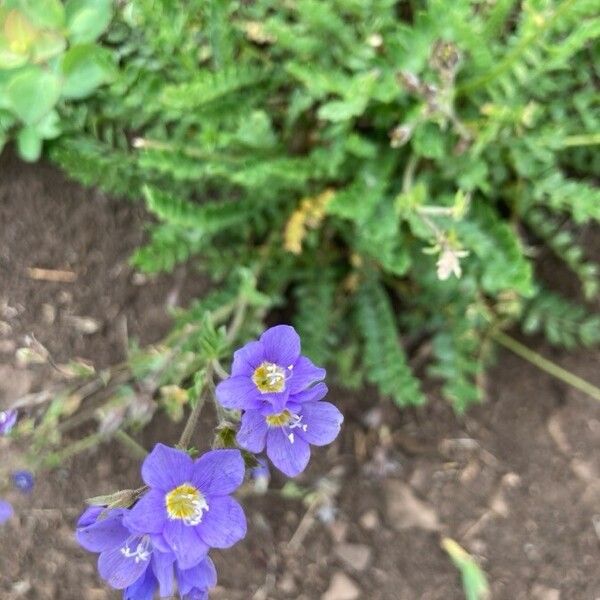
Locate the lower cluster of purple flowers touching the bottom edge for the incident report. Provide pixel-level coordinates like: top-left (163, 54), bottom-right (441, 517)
top-left (76, 444), bottom-right (246, 600)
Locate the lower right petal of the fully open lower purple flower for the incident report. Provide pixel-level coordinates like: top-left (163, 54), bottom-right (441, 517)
top-left (197, 496), bottom-right (247, 548)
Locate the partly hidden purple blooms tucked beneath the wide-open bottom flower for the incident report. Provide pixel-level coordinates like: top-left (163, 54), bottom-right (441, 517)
top-left (76, 507), bottom-right (217, 600)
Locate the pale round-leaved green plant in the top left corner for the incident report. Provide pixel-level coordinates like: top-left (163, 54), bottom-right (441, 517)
top-left (0, 0), bottom-right (114, 161)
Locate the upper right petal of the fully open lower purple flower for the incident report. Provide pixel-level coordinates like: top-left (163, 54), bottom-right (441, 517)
top-left (191, 450), bottom-right (246, 496)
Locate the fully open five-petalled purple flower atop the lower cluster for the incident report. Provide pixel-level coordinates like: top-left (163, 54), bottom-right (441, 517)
top-left (124, 444), bottom-right (246, 569)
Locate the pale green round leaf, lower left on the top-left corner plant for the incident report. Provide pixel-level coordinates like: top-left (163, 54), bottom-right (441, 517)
top-left (6, 66), bottom-right (60, 125)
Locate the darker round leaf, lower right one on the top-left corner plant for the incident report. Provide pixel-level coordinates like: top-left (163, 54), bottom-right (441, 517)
top-left (61, 44), bottom-right (114, 98)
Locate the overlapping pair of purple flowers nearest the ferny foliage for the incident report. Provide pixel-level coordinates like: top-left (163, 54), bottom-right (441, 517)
top-left (216, 325), bottom-right (344, 477)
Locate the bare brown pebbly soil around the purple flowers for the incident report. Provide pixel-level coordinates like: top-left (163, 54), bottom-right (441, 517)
top-left (0, 153), bottom-right (600, 600)
